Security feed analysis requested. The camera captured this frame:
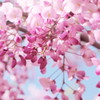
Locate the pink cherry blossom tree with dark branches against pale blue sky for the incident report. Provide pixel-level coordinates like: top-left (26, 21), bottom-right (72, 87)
top-left (0, 0), bottom-right (100, 100)
